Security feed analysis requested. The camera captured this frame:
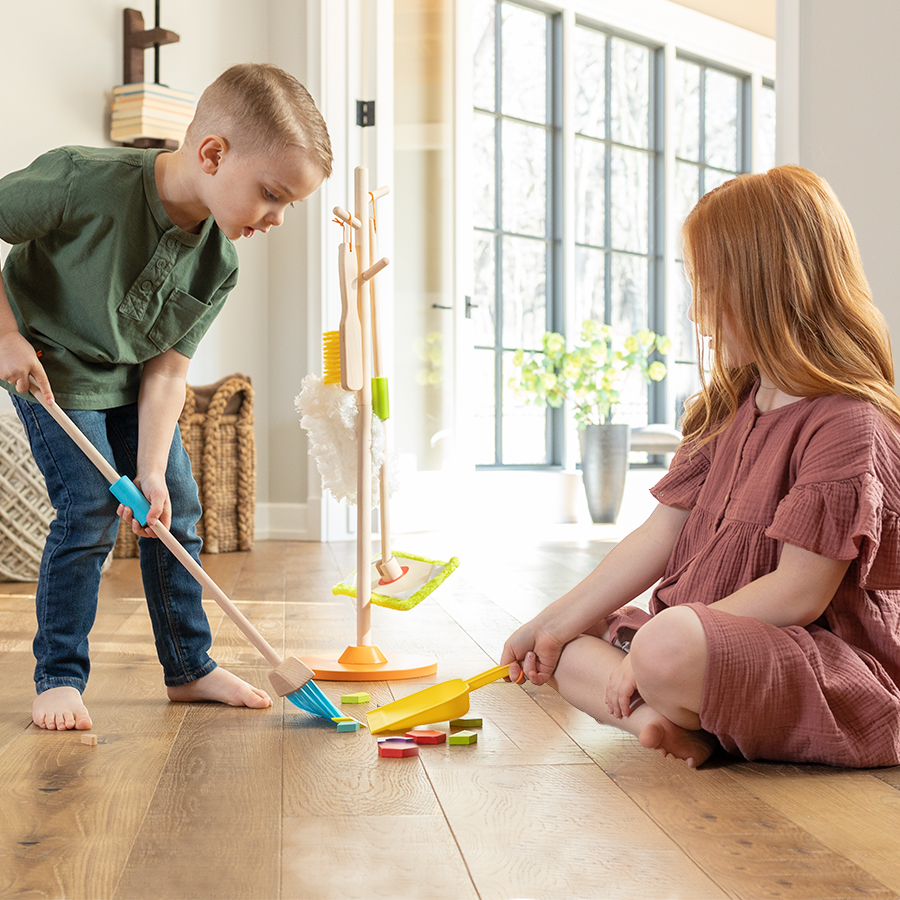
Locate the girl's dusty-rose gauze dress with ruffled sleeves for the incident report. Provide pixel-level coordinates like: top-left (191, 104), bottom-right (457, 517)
top-left (610, 389), bottom-right (900, 767)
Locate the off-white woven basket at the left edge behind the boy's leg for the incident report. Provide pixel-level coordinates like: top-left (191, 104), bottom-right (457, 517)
top-left (0, 412), bottom-right (56, 581)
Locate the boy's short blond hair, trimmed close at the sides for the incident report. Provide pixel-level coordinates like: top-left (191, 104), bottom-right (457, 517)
top-left (184, 63), bottom-right (332, 178)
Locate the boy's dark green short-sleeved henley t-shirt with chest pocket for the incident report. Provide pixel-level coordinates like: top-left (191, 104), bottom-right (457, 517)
top-left (0, 147), bottom-right (238, 409)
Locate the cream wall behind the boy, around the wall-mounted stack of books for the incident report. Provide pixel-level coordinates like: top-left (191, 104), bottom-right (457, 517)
top-left (0, 0), bottom-right (330, 536)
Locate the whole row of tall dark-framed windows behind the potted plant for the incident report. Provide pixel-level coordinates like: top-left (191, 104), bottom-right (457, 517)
top-left (470, 0), bottom-right (775, 466)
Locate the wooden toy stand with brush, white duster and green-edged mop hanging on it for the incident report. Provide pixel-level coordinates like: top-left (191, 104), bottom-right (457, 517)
top-left (297, 166), bottom-right (459, 681)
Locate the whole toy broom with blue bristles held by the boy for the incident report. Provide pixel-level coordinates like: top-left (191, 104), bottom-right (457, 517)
top-left (31, 378), bottom-right (352, 720)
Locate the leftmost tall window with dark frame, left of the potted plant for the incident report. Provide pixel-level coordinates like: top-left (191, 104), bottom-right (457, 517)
top-left (472, 0), bottom-right (559, 465)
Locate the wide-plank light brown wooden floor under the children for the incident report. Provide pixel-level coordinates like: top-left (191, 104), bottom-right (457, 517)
top-left (0, 531), bottom-right (900, 900)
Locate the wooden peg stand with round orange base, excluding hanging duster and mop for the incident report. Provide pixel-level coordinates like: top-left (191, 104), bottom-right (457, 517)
top-left (303, 166), bottom-right (437, 681)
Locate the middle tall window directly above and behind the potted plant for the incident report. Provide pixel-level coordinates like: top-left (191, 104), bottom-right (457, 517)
top-left (567, 27), bottom-right (662, 437)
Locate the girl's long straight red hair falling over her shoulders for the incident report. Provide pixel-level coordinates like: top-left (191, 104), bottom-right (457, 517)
top-left (682, 166), bottom-right (900, 443)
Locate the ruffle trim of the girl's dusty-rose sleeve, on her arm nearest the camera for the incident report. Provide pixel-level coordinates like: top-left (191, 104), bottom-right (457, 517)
top-left (766, 473), bottom-right (900, 590)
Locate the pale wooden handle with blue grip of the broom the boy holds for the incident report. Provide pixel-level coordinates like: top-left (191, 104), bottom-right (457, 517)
top-left (31, 378), bottom-right (284, 668)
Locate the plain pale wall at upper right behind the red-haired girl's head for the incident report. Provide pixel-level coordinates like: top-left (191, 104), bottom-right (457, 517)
top-left (777, 0), bottom-right (900, 376)
